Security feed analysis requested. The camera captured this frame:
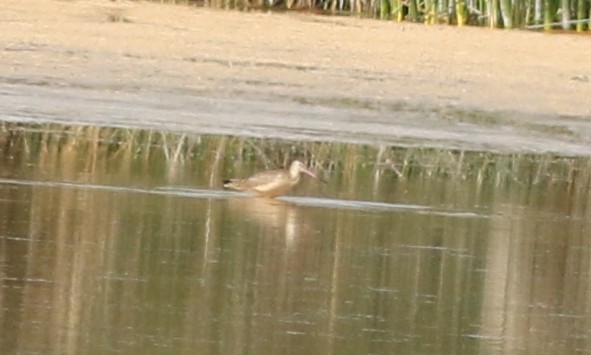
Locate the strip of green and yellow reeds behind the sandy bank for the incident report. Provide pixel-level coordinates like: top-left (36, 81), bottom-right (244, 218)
top-left (155, 0), bottom-right (591, 32)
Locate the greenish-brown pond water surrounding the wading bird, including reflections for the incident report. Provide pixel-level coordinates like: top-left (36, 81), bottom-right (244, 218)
top-left (0, 124), bottom-right (591, 354)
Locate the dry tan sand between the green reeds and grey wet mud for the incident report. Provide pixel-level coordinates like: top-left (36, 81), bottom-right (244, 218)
top-left (0, 0), bottom-right (591, 153)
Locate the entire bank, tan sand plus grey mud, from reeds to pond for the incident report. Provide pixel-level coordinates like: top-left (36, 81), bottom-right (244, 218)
top-left (0, 0), bottom-right (591, 155)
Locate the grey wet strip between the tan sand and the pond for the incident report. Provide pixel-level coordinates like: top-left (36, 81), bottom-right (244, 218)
top-left (0, 80), bottom-right (591, 156)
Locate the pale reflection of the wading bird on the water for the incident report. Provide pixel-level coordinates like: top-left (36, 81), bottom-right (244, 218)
top-left (228, 197), bottom-right (301, 248)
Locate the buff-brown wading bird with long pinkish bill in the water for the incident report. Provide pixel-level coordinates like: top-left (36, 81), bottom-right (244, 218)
top-left (224, 160), bottom-right (324, 197)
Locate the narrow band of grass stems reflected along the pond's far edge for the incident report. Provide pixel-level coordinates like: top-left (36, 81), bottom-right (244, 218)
top-left (0, 123), bottom-right (590, 191)
